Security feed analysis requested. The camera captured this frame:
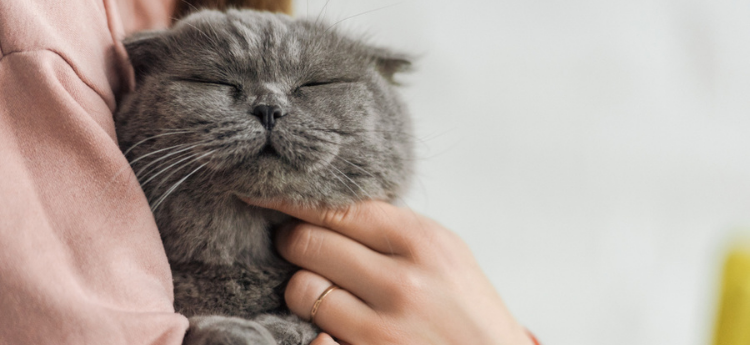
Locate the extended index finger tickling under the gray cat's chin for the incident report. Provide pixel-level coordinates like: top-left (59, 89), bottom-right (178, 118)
top-left (245, 200), bottom-right (426, 254)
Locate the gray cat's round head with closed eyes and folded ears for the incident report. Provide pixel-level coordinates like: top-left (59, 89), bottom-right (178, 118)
top-left (115, 11), bottom-right (413, 206)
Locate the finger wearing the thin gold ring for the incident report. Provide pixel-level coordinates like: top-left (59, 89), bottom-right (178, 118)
top-left (284, 270), bottom-right (377, 343)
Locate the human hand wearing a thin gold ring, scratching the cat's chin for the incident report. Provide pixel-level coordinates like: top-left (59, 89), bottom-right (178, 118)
top-left (247, 201), bottom-right (533, 345)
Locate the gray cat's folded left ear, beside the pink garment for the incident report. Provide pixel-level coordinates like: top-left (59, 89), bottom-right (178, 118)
top-left (122, 30), bottom-right (169, 83)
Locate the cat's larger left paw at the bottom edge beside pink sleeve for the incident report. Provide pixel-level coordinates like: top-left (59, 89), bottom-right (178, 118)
top-left (182, 316), bottom-right (277, 345)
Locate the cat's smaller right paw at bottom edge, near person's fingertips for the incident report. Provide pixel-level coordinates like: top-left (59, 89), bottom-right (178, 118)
top-left (253, 314), bottom-right (318, 345)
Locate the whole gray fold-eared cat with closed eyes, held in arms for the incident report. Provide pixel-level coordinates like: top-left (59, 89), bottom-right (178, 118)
top-left (115, 10), bottom-right (413, 345)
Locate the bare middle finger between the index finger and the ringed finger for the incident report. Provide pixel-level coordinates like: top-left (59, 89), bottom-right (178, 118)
top-left (276, 223), bottom-right (398, 305)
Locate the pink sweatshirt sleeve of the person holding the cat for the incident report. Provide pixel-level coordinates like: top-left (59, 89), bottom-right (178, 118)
top-left (0, 0), bottom-right (187, 345)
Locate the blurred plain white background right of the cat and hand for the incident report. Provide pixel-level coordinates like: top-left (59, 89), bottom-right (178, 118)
top-left (296, 0), bottom-right (750, 345)
